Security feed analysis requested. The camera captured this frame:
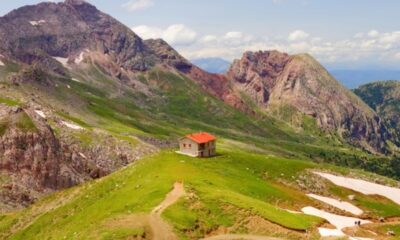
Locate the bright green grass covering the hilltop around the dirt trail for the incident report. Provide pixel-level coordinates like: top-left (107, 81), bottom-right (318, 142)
top-left (0, 145), bottom-right (328, 239)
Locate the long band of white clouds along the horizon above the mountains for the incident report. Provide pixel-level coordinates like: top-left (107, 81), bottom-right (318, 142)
top-left (133, 24), bottom-right (400, 67)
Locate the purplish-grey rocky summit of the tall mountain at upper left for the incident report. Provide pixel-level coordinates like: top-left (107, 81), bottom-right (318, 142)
top-left (0, 0), bottom-right (180, 73)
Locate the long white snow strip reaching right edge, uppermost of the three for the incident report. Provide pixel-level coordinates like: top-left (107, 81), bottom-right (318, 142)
top-left (314, 172), bottom-right (400, 205)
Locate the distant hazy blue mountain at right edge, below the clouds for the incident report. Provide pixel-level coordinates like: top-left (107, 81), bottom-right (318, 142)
top-left (329, 70), bottom-right (400, 89)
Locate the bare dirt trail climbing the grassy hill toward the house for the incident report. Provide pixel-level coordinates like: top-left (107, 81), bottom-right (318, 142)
top-left (148, 182), bottom-right (186, 240)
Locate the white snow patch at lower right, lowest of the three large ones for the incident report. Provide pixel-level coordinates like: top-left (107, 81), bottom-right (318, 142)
top-left (301, 207), bottom-right (371, 230)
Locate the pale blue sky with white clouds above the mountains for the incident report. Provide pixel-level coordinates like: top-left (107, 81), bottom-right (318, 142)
top-left (0, 0), bottom-right (400, 70)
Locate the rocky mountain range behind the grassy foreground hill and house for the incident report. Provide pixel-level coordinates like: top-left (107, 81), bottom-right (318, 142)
top-left (0, 0), bottom-right (396, 207)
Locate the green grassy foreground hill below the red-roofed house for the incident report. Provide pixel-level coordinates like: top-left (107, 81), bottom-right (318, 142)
top-left (0, 143), bottom-right (399, 239)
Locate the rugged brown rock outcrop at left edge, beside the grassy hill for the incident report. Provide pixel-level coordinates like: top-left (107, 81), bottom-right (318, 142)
top-left (0, 104), bottom-right (155, 207)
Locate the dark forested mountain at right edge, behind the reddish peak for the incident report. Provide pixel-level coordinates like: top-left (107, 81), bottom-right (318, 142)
top-left (354, 81), bottom-right (400, 144)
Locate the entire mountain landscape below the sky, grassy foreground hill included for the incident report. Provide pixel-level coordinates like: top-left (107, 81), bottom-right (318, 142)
top-left (0, 0), bottom-right (400, 239)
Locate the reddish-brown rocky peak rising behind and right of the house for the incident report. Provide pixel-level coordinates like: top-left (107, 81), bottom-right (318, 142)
top-left (227, 51), bottom-right (389, 151)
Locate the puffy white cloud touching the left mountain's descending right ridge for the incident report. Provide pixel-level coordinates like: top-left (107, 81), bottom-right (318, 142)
top-left (132, 24), bottom-right (197, 46)
